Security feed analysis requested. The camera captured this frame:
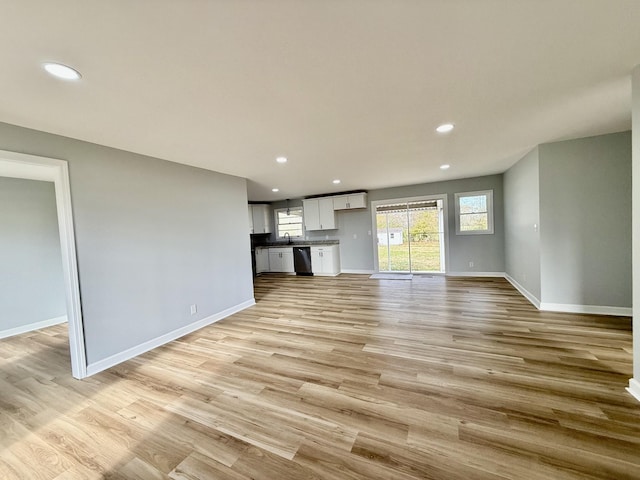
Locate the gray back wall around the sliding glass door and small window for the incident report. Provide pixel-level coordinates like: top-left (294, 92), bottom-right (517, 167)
top-left (307, 175), bottom-right (504, 274)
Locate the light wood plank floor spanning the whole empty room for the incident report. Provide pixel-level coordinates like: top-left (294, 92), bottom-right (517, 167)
top-left (0, 275), bottom-right (640, 480)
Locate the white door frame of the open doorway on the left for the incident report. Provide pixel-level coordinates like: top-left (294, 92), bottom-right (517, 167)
top-left (0, 150), bottom-right (87, 379)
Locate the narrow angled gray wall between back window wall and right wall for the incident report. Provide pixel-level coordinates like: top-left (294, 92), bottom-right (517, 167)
top-left (504, 147), bottom-right (541, 302)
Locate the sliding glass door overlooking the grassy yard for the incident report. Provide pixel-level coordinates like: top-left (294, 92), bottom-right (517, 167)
top-left (375, 199), bottom-right (445, 273)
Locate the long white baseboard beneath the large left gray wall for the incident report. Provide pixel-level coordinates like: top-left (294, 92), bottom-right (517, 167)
top-left (87, 298), bottom-right (256, 376)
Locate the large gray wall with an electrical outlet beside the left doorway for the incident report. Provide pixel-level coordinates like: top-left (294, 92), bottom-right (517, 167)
top-left (0, 124), bottom-right (253, 364)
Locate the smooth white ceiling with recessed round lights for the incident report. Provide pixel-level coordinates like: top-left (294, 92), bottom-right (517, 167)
top-left (0, 0), bottom-right (640, 201)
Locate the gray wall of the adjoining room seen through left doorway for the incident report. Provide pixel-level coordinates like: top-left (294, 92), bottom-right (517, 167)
top-left (0, 177), bottom-right (66, 332)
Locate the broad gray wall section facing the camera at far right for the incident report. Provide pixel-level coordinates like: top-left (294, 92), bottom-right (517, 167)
top-left (539, 132), bottom-right (631, 307)
